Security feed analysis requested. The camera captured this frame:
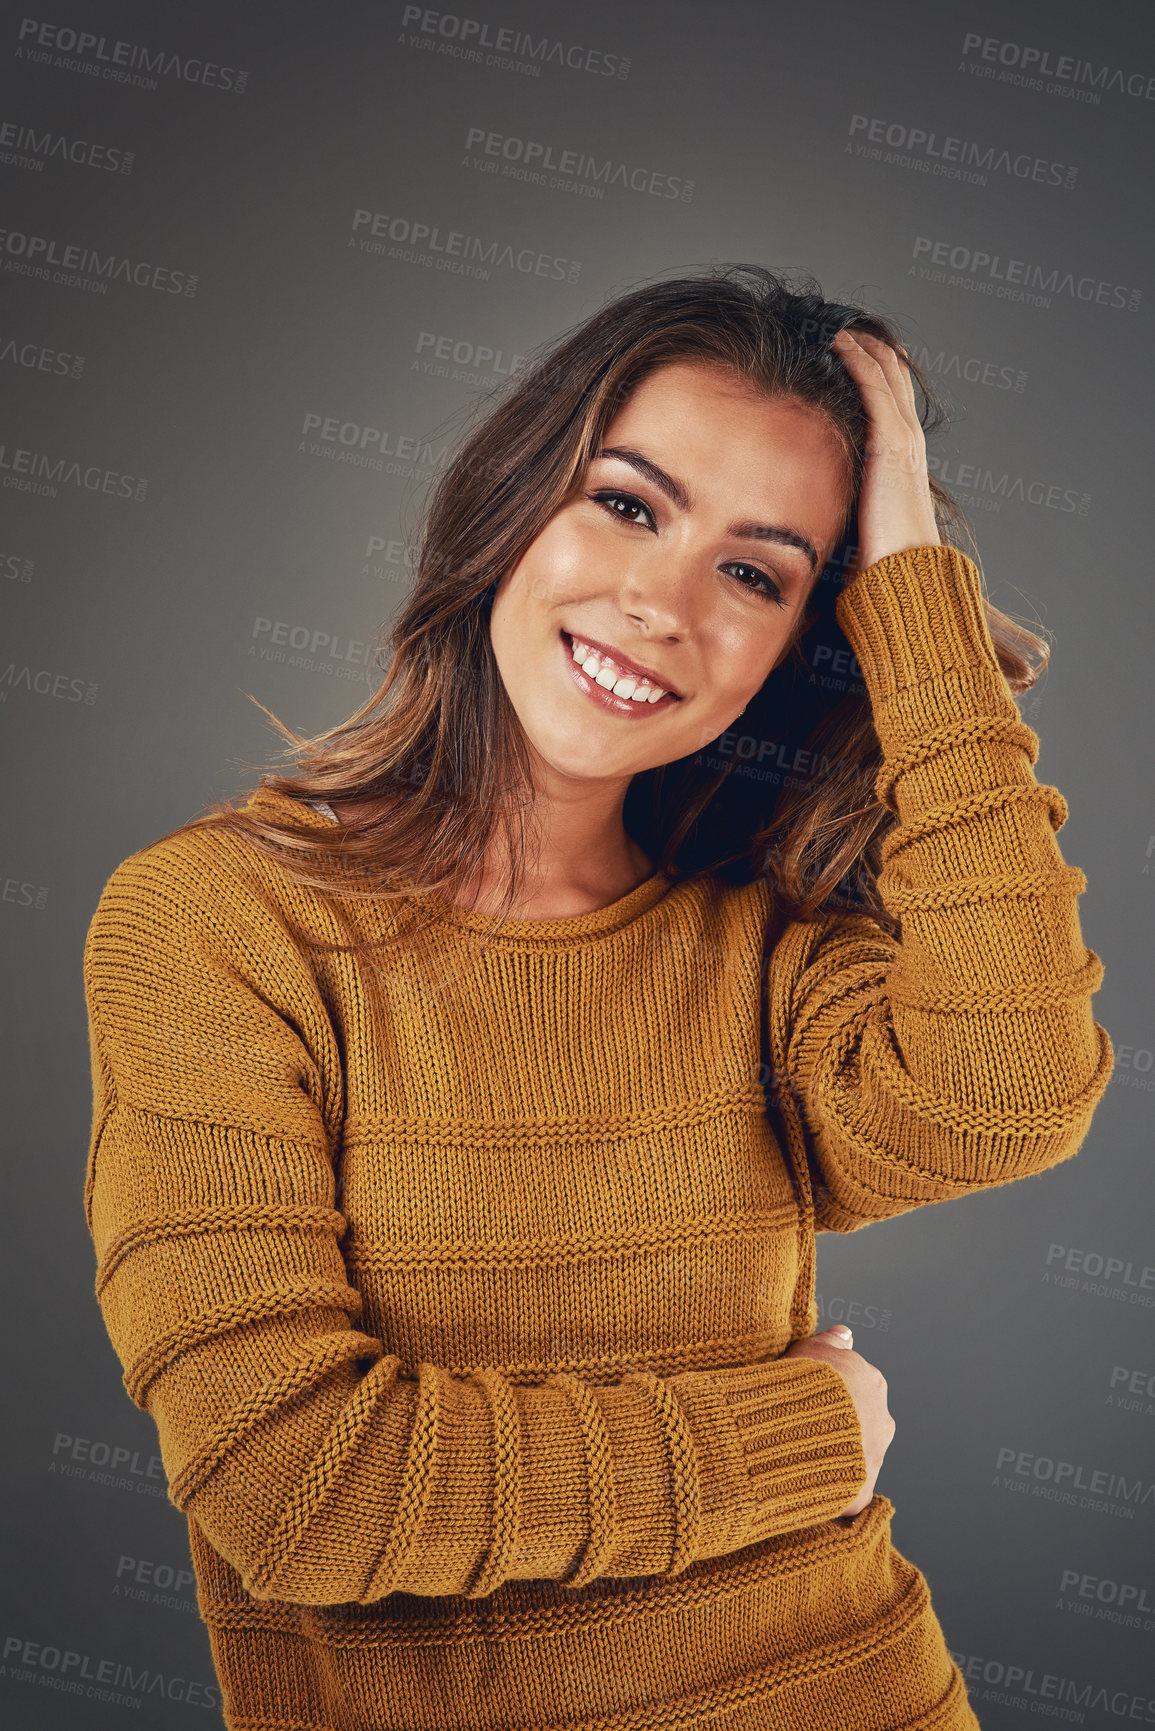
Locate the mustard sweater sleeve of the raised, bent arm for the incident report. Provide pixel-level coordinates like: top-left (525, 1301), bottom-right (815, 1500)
top-left (767, 547), bottom-right (1113, 1232)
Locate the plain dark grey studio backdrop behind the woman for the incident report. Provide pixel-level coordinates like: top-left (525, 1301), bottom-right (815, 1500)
top-left (0, 0), bottom-right (1155, 1728)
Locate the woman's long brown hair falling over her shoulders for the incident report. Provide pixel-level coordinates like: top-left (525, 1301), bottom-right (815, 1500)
top-left (158, 265), bottom-right (1049, 950)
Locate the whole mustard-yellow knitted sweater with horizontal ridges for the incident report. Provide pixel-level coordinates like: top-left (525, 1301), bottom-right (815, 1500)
top-left (85, 547), bottom-right (1113, 1731)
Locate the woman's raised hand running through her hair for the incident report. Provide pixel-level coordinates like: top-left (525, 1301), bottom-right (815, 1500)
top-left (831, 331), bottom-right (940, 575)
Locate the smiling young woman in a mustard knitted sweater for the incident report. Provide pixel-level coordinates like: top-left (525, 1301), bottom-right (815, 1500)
top-left (85, 267), bottom-right (1112, 1731)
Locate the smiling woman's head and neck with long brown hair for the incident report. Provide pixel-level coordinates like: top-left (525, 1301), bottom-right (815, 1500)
top-left (122, 267), bottom-right (1048, 942)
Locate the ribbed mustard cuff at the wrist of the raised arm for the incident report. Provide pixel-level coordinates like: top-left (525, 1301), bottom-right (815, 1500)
top-left (835, 545), bottom-right (1003, 703)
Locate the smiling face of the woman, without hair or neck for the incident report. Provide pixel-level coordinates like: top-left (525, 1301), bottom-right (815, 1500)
top-left (490, 360), bottom-right (850, 781)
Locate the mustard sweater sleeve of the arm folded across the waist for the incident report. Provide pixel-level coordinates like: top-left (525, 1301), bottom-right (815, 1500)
top-left (85, 836), bottom-right (866, 1605)
